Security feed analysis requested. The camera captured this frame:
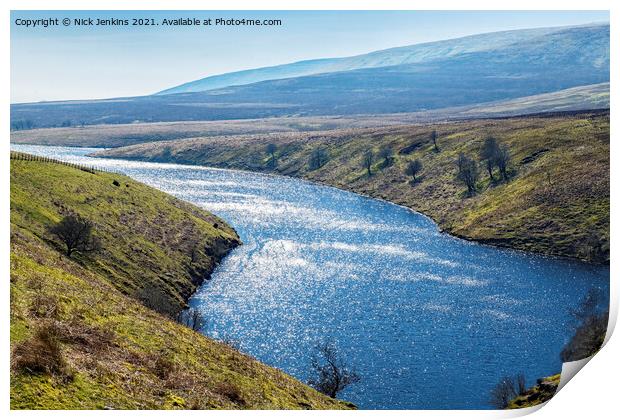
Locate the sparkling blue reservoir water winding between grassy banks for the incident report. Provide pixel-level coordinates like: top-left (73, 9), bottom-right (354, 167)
top-left (12, 145), bottom-right (609, 409)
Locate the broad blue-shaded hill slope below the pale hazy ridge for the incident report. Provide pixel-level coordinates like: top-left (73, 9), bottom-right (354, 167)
top-left (11, 25), bottom-right (609, 127)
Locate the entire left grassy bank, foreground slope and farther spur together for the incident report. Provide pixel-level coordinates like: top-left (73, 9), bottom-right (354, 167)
top-left (10, 160), bottom-right (350, 409)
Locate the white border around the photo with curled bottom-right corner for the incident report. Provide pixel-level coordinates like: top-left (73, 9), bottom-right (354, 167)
top-left (0, 0), bottom-right (620, 420)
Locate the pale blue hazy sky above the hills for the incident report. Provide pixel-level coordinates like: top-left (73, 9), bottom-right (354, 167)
top-left (11, 11), bottom-right (609, 103)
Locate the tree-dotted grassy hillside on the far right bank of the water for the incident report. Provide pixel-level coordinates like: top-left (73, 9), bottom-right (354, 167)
top-left (100, 112), bottom-right (609, 261)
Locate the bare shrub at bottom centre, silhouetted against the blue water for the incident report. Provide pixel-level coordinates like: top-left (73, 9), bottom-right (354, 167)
top-left (308, 341), bottom-right (361, 398)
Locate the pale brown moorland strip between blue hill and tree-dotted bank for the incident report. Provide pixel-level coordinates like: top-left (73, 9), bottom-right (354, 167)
top-left (11, 83), bottom-right (609, 147)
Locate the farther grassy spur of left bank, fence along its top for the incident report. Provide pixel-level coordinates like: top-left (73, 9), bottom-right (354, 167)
top-left (11, 160), bottom-right (239, 315)
